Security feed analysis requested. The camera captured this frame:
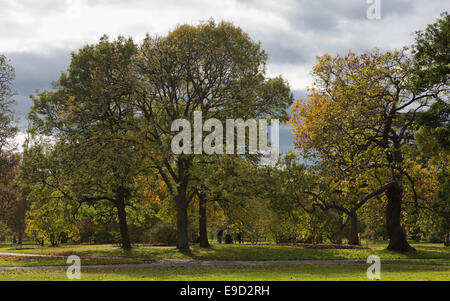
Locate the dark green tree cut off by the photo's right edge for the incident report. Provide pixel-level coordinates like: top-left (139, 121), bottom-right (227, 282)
top-left (413, 12), bottom-right (450, 245)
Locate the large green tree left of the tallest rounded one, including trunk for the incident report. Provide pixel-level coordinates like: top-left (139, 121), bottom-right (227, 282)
top-left (27, 36), bottom-right (147, 248)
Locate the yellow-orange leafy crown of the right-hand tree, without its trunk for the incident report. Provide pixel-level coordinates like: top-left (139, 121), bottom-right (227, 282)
top-left (290, 49), bottom-right (410, 164)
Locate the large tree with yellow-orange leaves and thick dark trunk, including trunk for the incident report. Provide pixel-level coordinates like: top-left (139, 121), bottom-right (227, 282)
top-left (291, 49), bottom-right (442, 251)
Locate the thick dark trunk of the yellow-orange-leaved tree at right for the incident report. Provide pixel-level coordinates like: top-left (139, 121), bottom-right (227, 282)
top-left (386, 183), bottom-right (415, 252)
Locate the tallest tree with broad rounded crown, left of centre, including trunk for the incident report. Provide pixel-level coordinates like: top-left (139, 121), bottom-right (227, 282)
top-left (136, 21), bottom-right (292, 250)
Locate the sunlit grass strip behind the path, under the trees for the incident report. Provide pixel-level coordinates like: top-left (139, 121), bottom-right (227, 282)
top-left (0, 239), bottom-right (450, 266)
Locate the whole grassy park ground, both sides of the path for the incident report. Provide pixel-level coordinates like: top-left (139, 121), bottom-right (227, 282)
top-left (0, 242), bottom-right (450, 281)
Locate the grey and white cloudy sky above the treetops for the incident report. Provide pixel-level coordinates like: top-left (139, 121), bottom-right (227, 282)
top-left (0, 0), bottom-right (450, 150)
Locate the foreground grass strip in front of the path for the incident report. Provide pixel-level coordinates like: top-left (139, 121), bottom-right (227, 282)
top-left (0, 265), bottom-right (450, 281)
